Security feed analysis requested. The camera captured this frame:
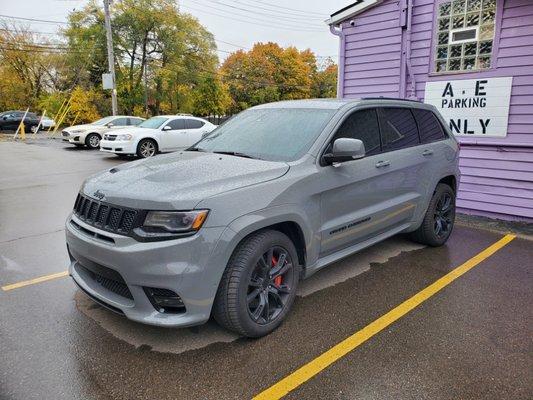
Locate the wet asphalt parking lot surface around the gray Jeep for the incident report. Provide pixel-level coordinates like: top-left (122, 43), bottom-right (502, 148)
top-left (0, 140), bottom-right (533, 399)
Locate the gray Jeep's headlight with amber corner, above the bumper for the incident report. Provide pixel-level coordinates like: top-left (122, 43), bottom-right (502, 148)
top-left (137, 210), bottom-right (209, 238)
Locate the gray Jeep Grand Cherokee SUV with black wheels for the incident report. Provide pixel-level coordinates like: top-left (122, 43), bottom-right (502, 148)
top-left (66, 99), bottom-right (459, 337)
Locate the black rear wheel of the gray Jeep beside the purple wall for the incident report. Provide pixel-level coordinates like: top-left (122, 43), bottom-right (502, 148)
top-left (410, 183), bottom-right (455, 247)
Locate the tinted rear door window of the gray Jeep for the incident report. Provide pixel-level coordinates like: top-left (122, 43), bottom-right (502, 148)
top-left (381, 108), bottom-right (419, 151)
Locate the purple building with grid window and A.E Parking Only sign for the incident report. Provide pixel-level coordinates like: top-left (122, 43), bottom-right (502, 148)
top-left (327, 0), bottom-right (533, 222)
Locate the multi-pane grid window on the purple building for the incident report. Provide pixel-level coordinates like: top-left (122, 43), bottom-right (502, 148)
top-left (435, 0), bottom-right (496, 72)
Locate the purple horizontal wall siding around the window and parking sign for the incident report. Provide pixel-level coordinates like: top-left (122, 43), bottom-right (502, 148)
top-left (343, 0), bottom-right (533, 221)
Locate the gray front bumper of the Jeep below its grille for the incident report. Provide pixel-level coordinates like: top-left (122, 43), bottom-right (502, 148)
top-left (66, 215), bottom-right (227, 327)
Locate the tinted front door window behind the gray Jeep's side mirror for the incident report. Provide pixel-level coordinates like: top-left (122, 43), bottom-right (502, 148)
top-left (334, 109), bottom-right (381, 156)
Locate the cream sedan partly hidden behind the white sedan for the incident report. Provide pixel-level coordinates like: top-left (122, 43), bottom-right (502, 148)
top-left (61, 115), bottom-right (144, 149)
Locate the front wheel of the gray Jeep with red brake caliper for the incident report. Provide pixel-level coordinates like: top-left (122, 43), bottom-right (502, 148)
top-left (213, 230), bottom-right (300, 338)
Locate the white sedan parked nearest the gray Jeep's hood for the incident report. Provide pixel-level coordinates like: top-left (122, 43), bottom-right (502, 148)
top-left (100, 115), bottom-right (216, 158)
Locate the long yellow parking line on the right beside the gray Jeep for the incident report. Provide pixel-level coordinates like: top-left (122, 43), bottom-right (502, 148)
top-left (254, 235), bottom-right (515, 400)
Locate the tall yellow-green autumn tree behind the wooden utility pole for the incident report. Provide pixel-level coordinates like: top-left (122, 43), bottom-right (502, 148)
top-left (65, 0), bottom-right (218, 114)
